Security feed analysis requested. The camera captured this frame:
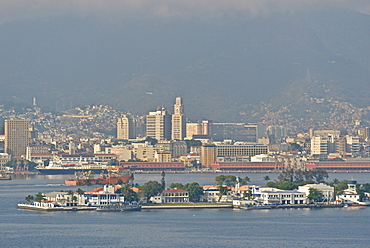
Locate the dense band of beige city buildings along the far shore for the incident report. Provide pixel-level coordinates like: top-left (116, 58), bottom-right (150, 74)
top-left (0, 96), bottom-right (370, 171)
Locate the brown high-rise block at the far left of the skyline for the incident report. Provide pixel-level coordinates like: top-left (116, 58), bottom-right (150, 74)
top-left (4, 119), bottom-right (30, 156)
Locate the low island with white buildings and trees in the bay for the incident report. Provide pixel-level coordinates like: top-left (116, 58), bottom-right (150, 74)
top-left (18, 170), bottom-right (370, 211)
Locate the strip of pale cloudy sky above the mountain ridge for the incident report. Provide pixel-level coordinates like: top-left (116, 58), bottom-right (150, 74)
top-left (0, 0), bottom-right (370, 22)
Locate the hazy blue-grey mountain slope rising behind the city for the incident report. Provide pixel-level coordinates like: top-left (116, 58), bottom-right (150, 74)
top-left (0, 11), bottom-right (370, 121)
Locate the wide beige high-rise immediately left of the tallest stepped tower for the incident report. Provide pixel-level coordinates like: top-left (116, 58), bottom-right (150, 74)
top-left (146, 108), bottom-right (171, 141)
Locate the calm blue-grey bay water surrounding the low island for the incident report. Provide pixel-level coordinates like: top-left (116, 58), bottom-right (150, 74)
top-left (0, 173), bottom-right (370, 247)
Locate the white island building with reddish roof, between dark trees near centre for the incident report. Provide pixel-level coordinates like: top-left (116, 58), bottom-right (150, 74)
top-left (150, 189), bottom-right (189, 204)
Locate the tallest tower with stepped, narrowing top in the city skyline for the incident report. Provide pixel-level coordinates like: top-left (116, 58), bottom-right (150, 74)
top-left (171, 97), bottom-right (186, 140)
